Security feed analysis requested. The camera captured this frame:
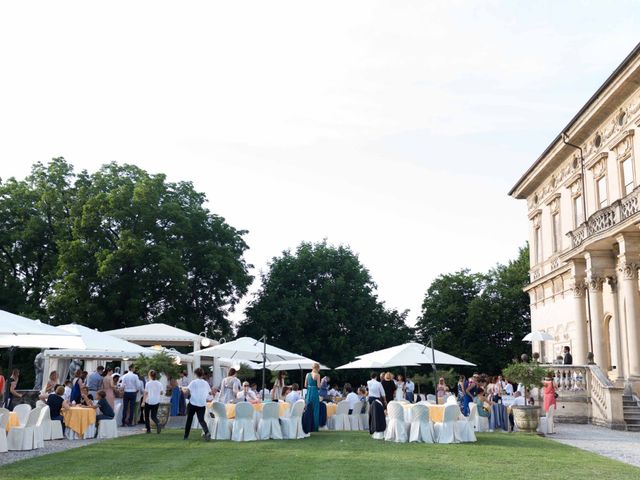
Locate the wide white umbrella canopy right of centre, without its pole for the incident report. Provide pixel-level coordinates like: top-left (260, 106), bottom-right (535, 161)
top-left (338, 342), bottom-right (474, 370)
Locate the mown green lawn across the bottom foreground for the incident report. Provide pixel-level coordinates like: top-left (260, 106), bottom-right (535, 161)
top-left (0, 430), bottom-right (640, 480)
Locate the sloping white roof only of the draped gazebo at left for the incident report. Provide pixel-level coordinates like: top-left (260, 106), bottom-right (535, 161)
top-left (45, 323), bottom-right (149, 359)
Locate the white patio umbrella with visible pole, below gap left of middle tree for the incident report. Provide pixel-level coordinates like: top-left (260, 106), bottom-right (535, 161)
top-left (192, 336), bottom-right (303, 400)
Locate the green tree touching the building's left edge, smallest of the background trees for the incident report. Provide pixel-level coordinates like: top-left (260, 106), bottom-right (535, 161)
top-left (416, 247), bottom-right (530, 373)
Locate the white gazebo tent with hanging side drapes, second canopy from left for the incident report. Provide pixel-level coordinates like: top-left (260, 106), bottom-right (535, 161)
top-left (43, 323), bottom-right (154, 384)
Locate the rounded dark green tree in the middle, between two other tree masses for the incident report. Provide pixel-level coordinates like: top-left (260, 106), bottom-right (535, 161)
top-left (238, 241), bottom-right (412, 366)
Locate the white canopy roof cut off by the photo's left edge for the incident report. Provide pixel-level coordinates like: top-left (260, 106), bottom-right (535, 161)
top-left (0, 310), bottom-right (85, 349)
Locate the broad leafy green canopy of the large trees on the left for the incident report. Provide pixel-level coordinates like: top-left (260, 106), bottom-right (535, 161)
top-left (0, 158), bottom-right (252, 335)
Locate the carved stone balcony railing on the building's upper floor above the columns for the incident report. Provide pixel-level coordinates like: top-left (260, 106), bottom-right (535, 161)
top-left (567, 186), bottom-right (640, 248)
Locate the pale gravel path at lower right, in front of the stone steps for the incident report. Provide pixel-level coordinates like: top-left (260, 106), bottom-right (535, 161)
top-left (547, 423), bottom-right (640, 467)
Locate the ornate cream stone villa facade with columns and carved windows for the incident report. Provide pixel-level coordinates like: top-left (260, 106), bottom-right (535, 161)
top-left (509, 44), bottom-right (640, 391)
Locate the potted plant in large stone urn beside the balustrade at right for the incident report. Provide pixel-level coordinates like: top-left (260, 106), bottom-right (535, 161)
top-left (502, 362), bottom-right (547, 433)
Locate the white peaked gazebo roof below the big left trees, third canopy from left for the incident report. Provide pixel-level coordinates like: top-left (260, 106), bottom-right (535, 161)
top-left (104, 323), bottom-right (218, 368)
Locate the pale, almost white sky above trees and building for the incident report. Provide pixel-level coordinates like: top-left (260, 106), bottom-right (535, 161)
top-left (0, 0), bottom-right (640, 323)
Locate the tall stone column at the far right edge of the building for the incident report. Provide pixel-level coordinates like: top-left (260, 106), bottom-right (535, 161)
top-left (616, 234), bottom-right (640, 378)
